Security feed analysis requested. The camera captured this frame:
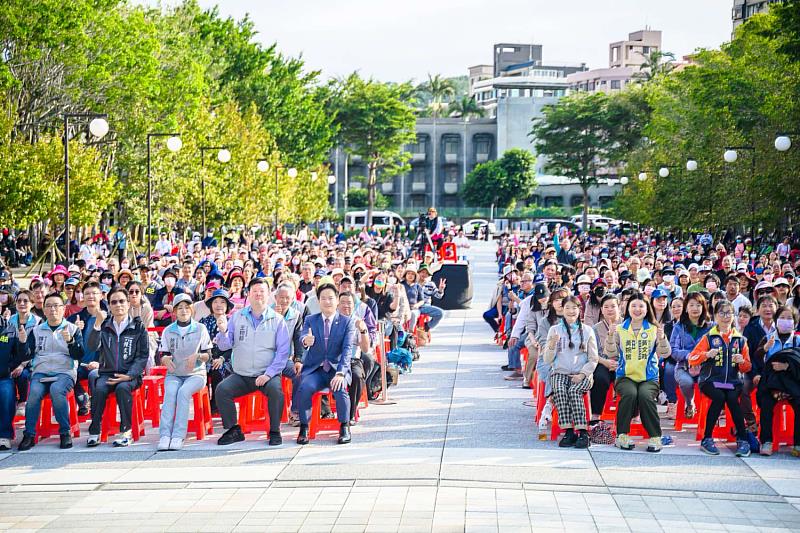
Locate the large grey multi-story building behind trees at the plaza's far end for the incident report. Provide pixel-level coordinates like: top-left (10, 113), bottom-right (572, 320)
top-left (331, 43), bottom-right (615, 213)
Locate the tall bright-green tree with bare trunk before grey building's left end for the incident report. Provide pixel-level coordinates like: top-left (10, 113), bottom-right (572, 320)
top-left (331, 74), bottom-right (416, 225)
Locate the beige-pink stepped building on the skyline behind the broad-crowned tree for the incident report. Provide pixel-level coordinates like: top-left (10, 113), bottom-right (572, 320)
top-left (567, 29), bottom-right (661, 93)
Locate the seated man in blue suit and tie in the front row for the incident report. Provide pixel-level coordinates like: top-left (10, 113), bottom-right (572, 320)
top-left (297, 280), bottom-right (356, 444)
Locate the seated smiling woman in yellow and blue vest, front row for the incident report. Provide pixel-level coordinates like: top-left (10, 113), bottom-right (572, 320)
top-left (604, 291), bottom-right (672, 452)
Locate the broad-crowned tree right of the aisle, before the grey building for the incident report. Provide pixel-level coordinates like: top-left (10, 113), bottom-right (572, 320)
top-left (531, 92), bottom-right (647, 230)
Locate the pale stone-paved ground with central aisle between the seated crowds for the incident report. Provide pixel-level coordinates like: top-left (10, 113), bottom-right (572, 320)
top-left (0, 243), bottom-right (800, 533)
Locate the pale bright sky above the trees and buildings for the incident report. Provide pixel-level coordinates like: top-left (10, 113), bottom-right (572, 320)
top-left (150, 0), bottom-right (733, 81)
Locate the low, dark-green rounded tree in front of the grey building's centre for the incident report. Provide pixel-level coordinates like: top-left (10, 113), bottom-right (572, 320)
top-left (461, 148), bottom-right (536, 207)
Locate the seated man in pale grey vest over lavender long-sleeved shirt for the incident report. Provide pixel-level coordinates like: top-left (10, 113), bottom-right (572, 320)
top-left (214, 278), bottom-right (290, 446)
